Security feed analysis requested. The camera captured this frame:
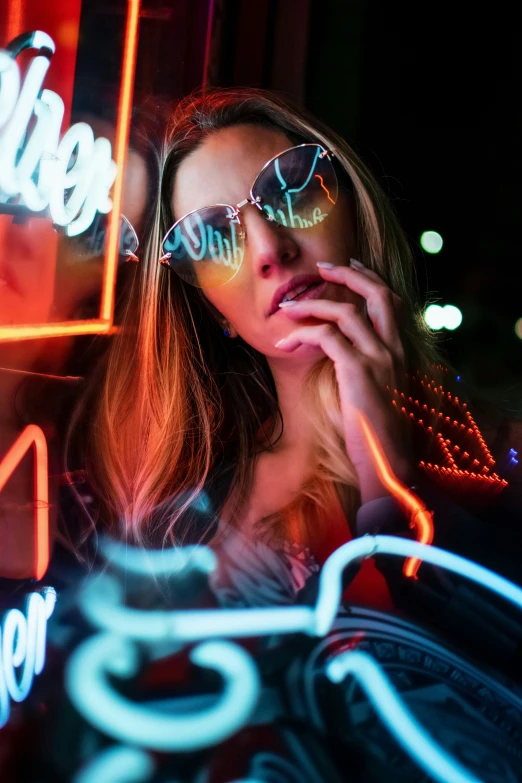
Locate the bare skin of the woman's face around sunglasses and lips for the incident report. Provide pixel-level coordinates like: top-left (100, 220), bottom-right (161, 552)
top-left (173, 125), bottom-right (362, 361)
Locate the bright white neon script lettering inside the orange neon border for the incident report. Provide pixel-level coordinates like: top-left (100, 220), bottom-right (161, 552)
top-left (0, 31), bottom-right (117, 236)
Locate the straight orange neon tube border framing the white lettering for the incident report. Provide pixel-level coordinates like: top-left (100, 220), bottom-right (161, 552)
top-left (0, 0), bottom-right (141, 343)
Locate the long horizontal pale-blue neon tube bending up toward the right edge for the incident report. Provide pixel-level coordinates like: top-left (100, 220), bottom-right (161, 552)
top-left (79, 536), bottom-right (522, 643)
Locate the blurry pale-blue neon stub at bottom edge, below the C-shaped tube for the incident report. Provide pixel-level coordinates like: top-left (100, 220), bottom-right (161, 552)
top-left (73, 745), bottom-right (155, 783)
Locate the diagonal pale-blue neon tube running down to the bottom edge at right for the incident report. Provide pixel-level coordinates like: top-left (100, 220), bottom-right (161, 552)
top-left (326, 651), bottom-right (481, 783)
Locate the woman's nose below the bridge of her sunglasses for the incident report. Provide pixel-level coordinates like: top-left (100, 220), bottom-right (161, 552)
top-left (241, 205), bottom-right (300, 277)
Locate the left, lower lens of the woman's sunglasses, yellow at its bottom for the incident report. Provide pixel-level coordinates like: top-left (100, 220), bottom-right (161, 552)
top-left (163, 206), bottom-right (244, 288)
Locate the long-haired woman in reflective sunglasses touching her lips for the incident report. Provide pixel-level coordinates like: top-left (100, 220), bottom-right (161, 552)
top-left (75, 89), bottom-right (516, 604)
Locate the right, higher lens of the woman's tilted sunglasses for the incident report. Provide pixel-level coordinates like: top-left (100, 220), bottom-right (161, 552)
top-left (252, 144), bottom-right (338, 228)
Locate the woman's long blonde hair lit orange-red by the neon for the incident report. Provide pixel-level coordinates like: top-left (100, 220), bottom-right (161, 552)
top-left (73, 88), bottom-right (439, 545)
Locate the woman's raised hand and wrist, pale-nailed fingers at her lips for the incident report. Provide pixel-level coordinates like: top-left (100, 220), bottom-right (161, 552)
top-left (276, 260), bottom-right (414, 503)
